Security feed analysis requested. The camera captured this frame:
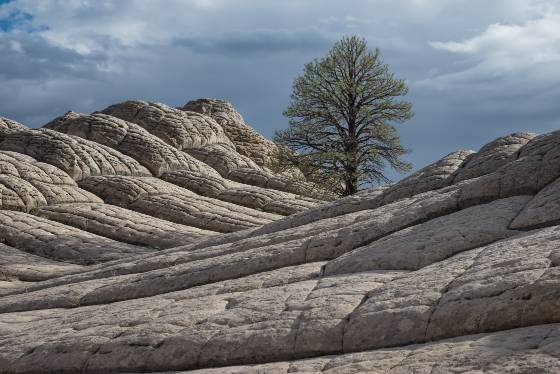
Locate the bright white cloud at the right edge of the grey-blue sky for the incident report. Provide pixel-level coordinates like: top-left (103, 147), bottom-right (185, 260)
top-left (422, 8), bottom-right (560, 89)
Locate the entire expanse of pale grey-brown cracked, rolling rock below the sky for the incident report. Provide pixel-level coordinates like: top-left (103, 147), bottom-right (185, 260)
top-left (0, 99), bottom-right (560, 374)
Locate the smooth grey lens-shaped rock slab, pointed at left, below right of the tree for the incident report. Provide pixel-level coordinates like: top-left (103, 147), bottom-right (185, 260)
top-left (325, 196), bottom-right (530, 274)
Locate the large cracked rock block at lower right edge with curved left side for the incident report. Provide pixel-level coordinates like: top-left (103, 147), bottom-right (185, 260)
top-left (426, 226), bottom-right (560, 339)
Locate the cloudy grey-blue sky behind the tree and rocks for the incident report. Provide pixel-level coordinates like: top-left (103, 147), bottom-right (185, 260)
top-left (0, 0), bottom-right (560, 180)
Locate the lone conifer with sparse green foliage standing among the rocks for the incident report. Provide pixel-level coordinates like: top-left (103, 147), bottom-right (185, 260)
top-left (274, 36), bottom-right (412, 196)
